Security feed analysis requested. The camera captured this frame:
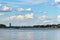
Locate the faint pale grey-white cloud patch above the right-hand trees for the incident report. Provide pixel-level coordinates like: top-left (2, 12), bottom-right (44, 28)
top-left (38, 15), bottom-right (54, 25)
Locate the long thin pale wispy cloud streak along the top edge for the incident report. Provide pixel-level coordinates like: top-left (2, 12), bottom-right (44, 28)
top-left (6, 0), bottom-right (48, 5)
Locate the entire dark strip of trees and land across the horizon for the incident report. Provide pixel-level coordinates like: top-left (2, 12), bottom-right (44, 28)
top-left (0, 24), bottom-right (60, 28)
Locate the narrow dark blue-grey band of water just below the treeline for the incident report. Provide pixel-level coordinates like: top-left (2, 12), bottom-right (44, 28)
top-left (0, 28), bottom-right (60, 30)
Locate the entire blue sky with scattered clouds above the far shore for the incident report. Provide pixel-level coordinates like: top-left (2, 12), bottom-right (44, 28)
top-left (0, 0), bottom-right (60, 26)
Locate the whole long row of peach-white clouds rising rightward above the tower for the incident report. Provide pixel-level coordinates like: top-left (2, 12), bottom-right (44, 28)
top-left (3, 13), bottom-right (33, 21)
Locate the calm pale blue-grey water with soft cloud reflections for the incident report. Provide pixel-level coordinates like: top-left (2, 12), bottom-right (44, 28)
top-left (0, 29), bottom-right (60, 40)
